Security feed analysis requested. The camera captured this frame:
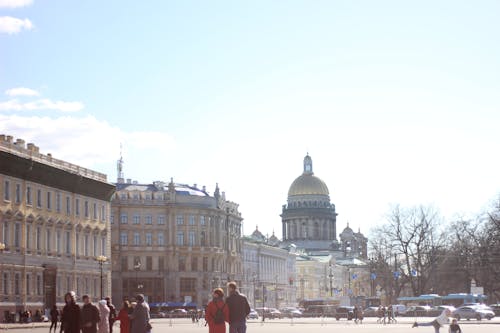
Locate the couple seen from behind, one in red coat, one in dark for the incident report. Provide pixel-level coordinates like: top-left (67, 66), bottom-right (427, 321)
top-left (205, 282), bottom-right (250, 333)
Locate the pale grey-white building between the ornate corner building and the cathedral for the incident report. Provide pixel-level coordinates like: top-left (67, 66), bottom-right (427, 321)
top-left (240, 228), bottom-right (296, 309)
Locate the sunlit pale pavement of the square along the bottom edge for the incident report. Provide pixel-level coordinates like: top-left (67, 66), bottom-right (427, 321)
top-left (0, 318), bottom-right (500, 333)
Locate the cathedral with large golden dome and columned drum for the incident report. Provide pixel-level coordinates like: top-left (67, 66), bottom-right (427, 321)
top-left (281, 154), bottom-right (368, 258)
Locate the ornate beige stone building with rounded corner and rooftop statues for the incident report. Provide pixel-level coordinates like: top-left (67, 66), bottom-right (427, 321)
top-left (111, 178), bottom-right (243, 307)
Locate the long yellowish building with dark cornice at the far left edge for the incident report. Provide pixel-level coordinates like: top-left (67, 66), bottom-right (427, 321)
top-left (0, 135), bottom-right (114, 320)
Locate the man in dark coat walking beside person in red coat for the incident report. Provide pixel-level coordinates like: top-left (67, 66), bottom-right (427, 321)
top-left (226, 282), bottom-right (250, 333)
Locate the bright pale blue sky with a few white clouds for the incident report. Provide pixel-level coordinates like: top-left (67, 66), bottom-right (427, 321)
top-left (0, 0), bottom-right (500, 237)
